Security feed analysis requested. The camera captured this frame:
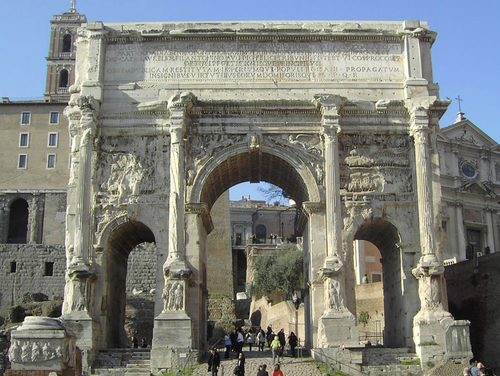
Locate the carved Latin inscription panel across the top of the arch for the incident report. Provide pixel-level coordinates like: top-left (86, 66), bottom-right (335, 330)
top-left (105, 42), bottom-right (404, 82)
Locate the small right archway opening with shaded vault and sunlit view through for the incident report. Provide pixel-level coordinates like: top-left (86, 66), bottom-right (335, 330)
top-left (354, 219), bottom-right (407, 347)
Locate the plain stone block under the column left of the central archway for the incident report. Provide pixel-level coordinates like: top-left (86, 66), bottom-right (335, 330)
top-left (151, 311), bottom-right (198, 372)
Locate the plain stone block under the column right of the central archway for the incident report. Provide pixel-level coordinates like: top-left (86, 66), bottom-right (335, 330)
top-left (319, 310), bottom-right (359, 347)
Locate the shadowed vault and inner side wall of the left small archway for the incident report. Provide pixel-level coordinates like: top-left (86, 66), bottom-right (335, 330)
top-left (104, 221), bottom-right (156, 348)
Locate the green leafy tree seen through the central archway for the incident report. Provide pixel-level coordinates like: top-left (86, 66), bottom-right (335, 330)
top-left (248, 242), bottom-right (304, 296)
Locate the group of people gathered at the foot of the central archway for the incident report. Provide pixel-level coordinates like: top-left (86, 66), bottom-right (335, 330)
top-left (208, 326), bottom-right (299, 376)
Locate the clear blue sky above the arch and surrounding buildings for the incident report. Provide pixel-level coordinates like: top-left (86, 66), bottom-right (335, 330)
top-left (0, 0), bottom-right (500, 198)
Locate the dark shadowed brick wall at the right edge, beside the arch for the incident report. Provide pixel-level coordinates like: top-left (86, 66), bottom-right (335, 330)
top-left (445, 252), bottom-right (500, 374)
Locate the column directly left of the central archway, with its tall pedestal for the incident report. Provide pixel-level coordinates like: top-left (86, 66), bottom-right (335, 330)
top-left (151, 93), bottom-right (198, 369)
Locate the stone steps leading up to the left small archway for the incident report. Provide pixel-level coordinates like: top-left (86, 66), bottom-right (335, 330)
top-left (91, 349), bottom-right (151, 376)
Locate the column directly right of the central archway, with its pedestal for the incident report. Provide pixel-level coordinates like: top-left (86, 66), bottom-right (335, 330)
top-left (315, 95), bottom-right (359, 347)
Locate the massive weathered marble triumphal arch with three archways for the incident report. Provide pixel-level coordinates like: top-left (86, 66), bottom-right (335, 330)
top-left (56, 21), bottom-right (468, 369)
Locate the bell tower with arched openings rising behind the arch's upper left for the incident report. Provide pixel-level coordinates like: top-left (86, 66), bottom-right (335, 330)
top-left (44, 0), bottom-right (87, 102)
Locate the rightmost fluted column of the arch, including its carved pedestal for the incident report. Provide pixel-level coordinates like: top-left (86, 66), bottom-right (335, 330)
top-left (409, 102), bottom-right (454, 364)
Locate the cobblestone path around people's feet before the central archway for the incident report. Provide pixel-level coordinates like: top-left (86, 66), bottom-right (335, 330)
top-left (188, 350), bottom-right (322, 376)
